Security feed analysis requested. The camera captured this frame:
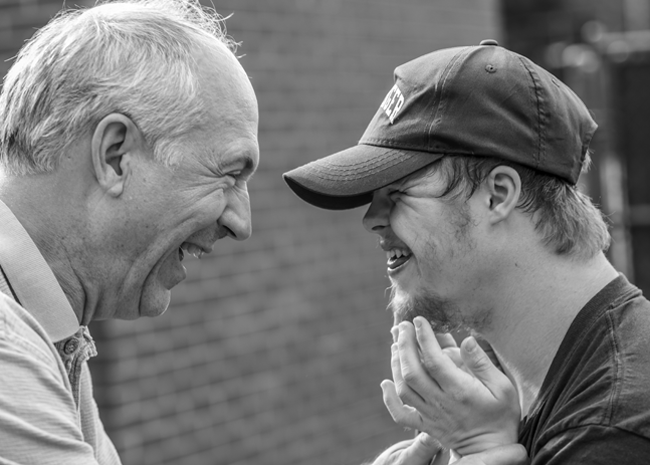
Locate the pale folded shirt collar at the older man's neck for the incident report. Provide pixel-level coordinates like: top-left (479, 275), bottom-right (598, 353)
top-left (0, 201), bottom-right (79, 342)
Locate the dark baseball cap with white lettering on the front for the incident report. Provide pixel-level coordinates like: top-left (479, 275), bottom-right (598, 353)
top-left (283, 40), bottom-right (598, 210)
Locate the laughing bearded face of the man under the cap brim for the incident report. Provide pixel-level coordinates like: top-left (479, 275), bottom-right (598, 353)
top-left (363, 163), bottom-right (480, 331)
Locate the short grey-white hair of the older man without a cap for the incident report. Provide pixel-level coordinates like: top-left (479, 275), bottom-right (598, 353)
top-left (0, 0), bottom-right (236, 175)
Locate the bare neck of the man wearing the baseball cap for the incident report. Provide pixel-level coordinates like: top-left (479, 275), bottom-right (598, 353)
top-left (481, 253), bottom-right (618, 415)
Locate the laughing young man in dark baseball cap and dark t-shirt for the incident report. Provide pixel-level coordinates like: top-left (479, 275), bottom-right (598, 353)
top-left (285, 41), bottom-right (650, 465)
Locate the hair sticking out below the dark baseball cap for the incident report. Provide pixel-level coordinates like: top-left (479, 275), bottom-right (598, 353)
top-left (432, 155), bottom-right (611, 259)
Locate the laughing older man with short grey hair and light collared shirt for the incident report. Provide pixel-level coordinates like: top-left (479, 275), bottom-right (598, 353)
top-left (0, 0), bottom-right (259, 465)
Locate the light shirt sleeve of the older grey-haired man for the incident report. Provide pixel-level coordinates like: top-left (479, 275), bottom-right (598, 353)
top-left (0, 302), bottom-right (97, 465)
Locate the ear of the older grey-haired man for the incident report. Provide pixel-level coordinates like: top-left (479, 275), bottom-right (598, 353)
top-left (91, 113), bottom-right (146, 197)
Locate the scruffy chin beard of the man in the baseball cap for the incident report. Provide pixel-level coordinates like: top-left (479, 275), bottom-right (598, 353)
top-left (388, 285), bottom-right (465, 333)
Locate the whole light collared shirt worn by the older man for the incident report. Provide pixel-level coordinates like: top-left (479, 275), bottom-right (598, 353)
top-left (0, 201), bottom-right (121, 465)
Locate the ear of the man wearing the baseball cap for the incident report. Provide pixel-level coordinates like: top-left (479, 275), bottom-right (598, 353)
top-left (485, 165), bottom-right (521, 224)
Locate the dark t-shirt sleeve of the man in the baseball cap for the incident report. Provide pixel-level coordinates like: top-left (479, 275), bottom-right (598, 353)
top-left (531, 425), bottom-right (650, 465)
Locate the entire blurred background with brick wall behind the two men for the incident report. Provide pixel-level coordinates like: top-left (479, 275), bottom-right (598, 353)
top-left (0, 0), bottom-right (650, 465)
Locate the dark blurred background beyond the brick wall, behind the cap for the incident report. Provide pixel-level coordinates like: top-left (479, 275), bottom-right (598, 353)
top-left (502, 0), bottom-right (650, 288)
